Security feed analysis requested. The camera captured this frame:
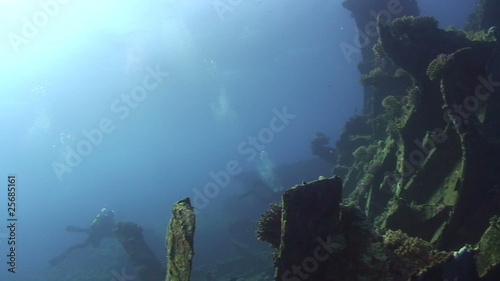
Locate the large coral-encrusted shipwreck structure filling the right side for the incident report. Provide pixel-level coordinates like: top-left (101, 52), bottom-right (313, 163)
top-left (259, 0), bottom-right (500, 281)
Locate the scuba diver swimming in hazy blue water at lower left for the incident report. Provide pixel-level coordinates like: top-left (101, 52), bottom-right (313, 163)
top-left (50, 208), bottom-right (115, 266)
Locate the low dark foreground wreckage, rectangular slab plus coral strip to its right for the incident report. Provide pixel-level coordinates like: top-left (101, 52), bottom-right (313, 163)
top-left (259, 177), bottom-right (498, 281)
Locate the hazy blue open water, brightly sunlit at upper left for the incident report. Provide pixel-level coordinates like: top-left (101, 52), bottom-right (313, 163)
top-left (0, 0), bottom-right (475, 280)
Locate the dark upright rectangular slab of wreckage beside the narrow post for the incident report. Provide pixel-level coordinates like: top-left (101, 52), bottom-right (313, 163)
top-left (275, 177), bottom-right (342, 281)
